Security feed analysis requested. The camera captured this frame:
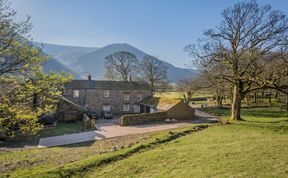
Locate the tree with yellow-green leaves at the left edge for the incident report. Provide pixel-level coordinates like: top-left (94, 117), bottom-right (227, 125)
top-left (0, 0), bottom-right (71, 137)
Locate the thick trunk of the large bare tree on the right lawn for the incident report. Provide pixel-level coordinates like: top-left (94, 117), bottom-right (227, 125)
top-left (231, 84), bottom-right (242, 120)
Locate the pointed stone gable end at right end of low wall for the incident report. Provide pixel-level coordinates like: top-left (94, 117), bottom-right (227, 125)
top-left (166, 102), bottom-right (195, 120)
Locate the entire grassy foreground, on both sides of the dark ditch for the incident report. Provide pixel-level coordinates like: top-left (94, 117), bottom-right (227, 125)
top-left (0, 108), bottom-right (288, 178)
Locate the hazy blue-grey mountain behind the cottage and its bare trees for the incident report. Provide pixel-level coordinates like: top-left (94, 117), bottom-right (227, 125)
top-left (38, 43), bottom-right (197, 82)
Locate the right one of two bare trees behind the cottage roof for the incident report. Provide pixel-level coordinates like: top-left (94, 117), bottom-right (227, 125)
top-left (140, 55), bottom-right (167, 91)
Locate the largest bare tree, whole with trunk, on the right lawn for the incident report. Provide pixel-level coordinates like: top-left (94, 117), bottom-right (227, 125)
top-left (185, 1), bottom-right (288, 120)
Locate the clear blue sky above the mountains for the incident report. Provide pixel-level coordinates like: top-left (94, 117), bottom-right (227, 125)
top-left (11, 0), bottom-right (288, 67)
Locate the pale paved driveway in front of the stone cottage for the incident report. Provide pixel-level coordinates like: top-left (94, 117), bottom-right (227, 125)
top-left (38, 111), bottom-right (218, 148)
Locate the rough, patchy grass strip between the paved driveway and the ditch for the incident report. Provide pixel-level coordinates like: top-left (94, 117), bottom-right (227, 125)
top-left (0, 133), bottom-right (156, 177)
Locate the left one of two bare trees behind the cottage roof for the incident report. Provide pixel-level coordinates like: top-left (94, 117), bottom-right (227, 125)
top-left (105, 51), bottom-right (138, 81)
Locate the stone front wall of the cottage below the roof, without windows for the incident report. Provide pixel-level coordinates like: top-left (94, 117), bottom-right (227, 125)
top-left (64, 89), bottom-right (152, 114)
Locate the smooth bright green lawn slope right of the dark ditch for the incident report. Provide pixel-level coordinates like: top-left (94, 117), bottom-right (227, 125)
top-left (87, 108), bottom-right (288, 177)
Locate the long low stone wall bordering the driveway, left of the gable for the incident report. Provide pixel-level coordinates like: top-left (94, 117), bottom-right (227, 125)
top-left (119, 112), bottom-right (167, 126)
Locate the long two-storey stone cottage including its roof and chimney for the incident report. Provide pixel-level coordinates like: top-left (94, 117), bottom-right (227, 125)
top-left (59, 76), bottom-right (152, 120)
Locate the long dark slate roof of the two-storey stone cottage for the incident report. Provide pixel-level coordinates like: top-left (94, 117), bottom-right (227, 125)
top-left (65, 80), bottom-right (151, 90)
